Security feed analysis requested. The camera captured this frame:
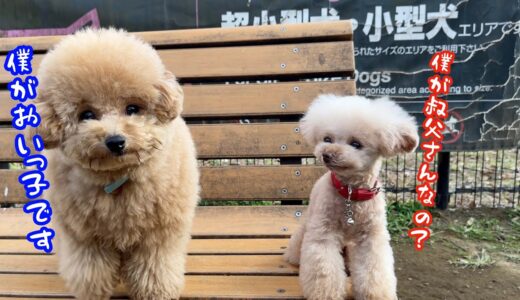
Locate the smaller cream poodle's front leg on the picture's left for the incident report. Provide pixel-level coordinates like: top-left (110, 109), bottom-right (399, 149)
top-left (300, 229), bottom-right (348, 300)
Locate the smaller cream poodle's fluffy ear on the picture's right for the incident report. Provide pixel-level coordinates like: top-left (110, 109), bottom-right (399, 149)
top-left (375, 98), bottom-right (419, 157)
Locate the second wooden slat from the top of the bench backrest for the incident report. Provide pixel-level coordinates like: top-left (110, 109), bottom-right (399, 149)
top-left (0, 42), bottom-right (354, 83)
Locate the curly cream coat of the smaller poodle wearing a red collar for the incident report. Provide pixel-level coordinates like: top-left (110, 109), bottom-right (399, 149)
top-left (285, 95), bottom-right (419, 300)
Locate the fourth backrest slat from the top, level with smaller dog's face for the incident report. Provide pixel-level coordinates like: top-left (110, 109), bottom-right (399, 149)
top-left (0, 122), bottom-right (313, 161)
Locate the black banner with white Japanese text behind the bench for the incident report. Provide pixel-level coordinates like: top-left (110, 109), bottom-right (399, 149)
top-left (0, 0), bottom-right (520, 150)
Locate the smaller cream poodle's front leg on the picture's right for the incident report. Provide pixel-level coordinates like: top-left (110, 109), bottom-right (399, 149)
top-left (348, 226), bottom-right (397, 300)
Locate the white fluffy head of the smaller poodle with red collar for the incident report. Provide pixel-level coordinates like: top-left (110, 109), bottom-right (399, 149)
top-left (300, 95), bottom-right (419, 182)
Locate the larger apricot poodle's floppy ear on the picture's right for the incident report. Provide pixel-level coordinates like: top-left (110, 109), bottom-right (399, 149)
top-left (155, 71), bottom-right (184, 123)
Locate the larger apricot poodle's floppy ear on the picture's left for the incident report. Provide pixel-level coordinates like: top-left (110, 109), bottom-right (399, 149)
top-left (26, 91), bottom-right (63, 149)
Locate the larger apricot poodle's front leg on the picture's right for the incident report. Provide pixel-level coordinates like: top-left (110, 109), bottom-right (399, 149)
top-left (123, 234), bottom-right (189, 300)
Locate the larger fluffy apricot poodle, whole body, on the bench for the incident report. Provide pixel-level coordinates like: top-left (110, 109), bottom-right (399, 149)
top-left (31, 29), bottom-right (199, 300)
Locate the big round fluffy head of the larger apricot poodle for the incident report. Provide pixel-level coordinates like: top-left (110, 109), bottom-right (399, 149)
top-left (32, 29), bottom-right (183, 171)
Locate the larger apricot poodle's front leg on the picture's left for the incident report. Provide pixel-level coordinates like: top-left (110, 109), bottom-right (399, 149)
top-left (58, 231), bottom-right (120, 300)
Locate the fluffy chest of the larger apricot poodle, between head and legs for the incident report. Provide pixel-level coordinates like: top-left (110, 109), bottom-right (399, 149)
top-left (44, 145), bottom-right (196, 251)
